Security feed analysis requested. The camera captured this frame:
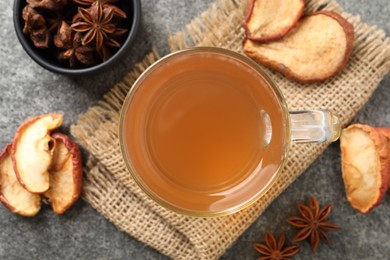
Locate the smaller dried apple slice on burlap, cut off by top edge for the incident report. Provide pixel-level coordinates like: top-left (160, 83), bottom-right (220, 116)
top-left (244, 0), bottom-right (305, 42)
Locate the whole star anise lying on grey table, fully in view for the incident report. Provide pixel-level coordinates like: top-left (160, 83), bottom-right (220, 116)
top-left (287, 196), bottom-right (341, 252)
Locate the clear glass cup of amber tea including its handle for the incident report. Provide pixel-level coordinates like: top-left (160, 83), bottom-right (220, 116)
top-left (119, 47), bottom-right (340, 217)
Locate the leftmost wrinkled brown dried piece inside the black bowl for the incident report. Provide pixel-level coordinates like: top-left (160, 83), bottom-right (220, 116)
top-left (22, 5), bottom-right (49, 49)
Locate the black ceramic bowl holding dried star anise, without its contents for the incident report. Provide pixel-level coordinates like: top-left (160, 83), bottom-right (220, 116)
top-left (14, 0), bottom-right (141, 76)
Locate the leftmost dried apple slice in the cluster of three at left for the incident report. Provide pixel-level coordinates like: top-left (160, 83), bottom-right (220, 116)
top-left (0, 145), bottom-right (41, 217)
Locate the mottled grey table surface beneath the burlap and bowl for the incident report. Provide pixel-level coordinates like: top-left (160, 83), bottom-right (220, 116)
top-left (0, 0), bottom-right (390, 259)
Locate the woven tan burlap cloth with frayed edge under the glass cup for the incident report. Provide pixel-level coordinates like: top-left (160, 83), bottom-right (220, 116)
top-left (71, 0), bottom-right (390, 259)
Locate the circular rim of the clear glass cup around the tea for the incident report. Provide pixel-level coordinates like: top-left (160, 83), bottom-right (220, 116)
top-left (119, 47), bottom-right (291, 217)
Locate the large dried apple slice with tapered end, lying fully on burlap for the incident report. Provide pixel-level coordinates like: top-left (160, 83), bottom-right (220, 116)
top-left (244, 11), bottom-right (354, 83)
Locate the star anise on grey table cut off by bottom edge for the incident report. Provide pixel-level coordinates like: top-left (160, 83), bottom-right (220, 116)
top-left (254, 232), bottom-right (299, 260)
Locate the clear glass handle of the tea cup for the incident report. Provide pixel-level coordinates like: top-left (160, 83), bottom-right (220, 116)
top-left (290, 110), bottom-right (341, 144)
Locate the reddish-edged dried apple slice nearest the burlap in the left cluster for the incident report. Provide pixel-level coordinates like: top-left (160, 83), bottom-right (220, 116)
top-left (44, 133), bottom-right (83, 214)
